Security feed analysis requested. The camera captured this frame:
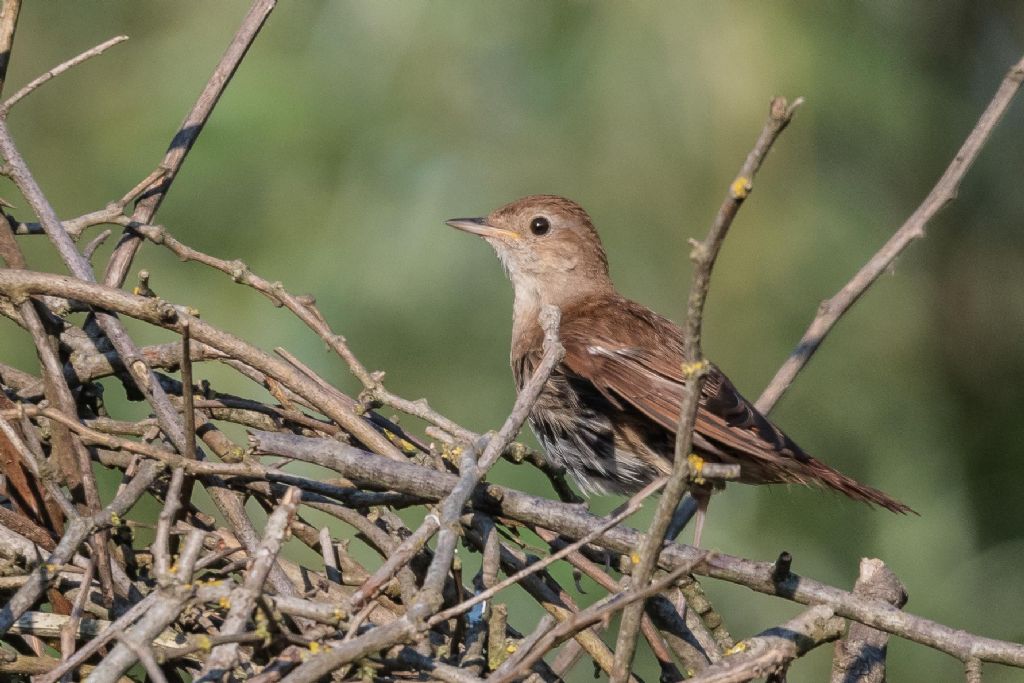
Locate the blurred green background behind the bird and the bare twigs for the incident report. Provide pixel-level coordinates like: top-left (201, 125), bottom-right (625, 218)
top-left (0, 0), bottom-right (1024, 682)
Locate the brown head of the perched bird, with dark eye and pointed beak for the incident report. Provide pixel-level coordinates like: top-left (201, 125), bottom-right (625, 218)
top-left (446, 195), bottom-right (611, 305)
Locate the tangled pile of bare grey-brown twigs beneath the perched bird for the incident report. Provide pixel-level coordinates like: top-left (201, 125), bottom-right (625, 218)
top-left (0, 0), bottom-right (1024, 683)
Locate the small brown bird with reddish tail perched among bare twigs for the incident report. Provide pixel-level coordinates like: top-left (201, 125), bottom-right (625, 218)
top-left (447, 195), bottom-right (911, 527)
